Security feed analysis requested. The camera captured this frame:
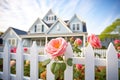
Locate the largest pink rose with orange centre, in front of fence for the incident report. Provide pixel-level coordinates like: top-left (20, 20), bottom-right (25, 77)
top-left (45, 38), bottom-right (68, 59)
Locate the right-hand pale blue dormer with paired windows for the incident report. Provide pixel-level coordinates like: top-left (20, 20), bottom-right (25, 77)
top-left (68, 14), bottom-right (87, 32)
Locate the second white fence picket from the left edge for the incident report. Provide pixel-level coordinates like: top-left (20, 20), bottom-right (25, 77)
top-left (16, 41), bottom-right (24, 80)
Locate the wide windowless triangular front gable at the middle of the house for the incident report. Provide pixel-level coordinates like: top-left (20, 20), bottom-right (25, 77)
top-left (47, 20), bottom-right (72, 34)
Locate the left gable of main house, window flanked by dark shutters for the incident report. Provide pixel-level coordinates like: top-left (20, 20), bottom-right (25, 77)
top-left (29, 18), bottom-right (49, 33)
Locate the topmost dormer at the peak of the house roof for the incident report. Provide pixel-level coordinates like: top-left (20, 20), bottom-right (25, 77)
top-left (43, 9), bottom-right (57, 24)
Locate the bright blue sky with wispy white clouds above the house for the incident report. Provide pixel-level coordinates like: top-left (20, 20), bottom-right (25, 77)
top-left (0, 0), bottom-right (120, 34)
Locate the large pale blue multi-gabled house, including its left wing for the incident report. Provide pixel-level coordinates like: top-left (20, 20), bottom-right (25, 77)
top-left (3, 9), bottom-right (88, 52)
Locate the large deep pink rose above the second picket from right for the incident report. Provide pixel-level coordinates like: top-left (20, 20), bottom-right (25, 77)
top-left (87, 34), bottom-right (101, 48)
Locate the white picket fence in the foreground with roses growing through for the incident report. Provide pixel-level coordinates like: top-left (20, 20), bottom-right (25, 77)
top-left (0, 42), bottom-right (120, 80)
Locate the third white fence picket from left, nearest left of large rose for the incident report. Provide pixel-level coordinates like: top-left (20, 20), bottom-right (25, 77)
top-left (30, 41), bottom-right (38, 80)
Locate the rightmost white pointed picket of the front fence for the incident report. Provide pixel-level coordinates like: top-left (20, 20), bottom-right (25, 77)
top-left (106, 43), bottom-right (118, 80)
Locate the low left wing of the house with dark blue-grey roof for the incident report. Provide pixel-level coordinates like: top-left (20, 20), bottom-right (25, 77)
top-left (1, 27), bottom-right (27, 47)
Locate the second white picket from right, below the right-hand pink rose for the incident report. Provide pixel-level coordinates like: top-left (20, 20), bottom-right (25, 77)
top-left (85, 44), bottom-right (95, 80)
